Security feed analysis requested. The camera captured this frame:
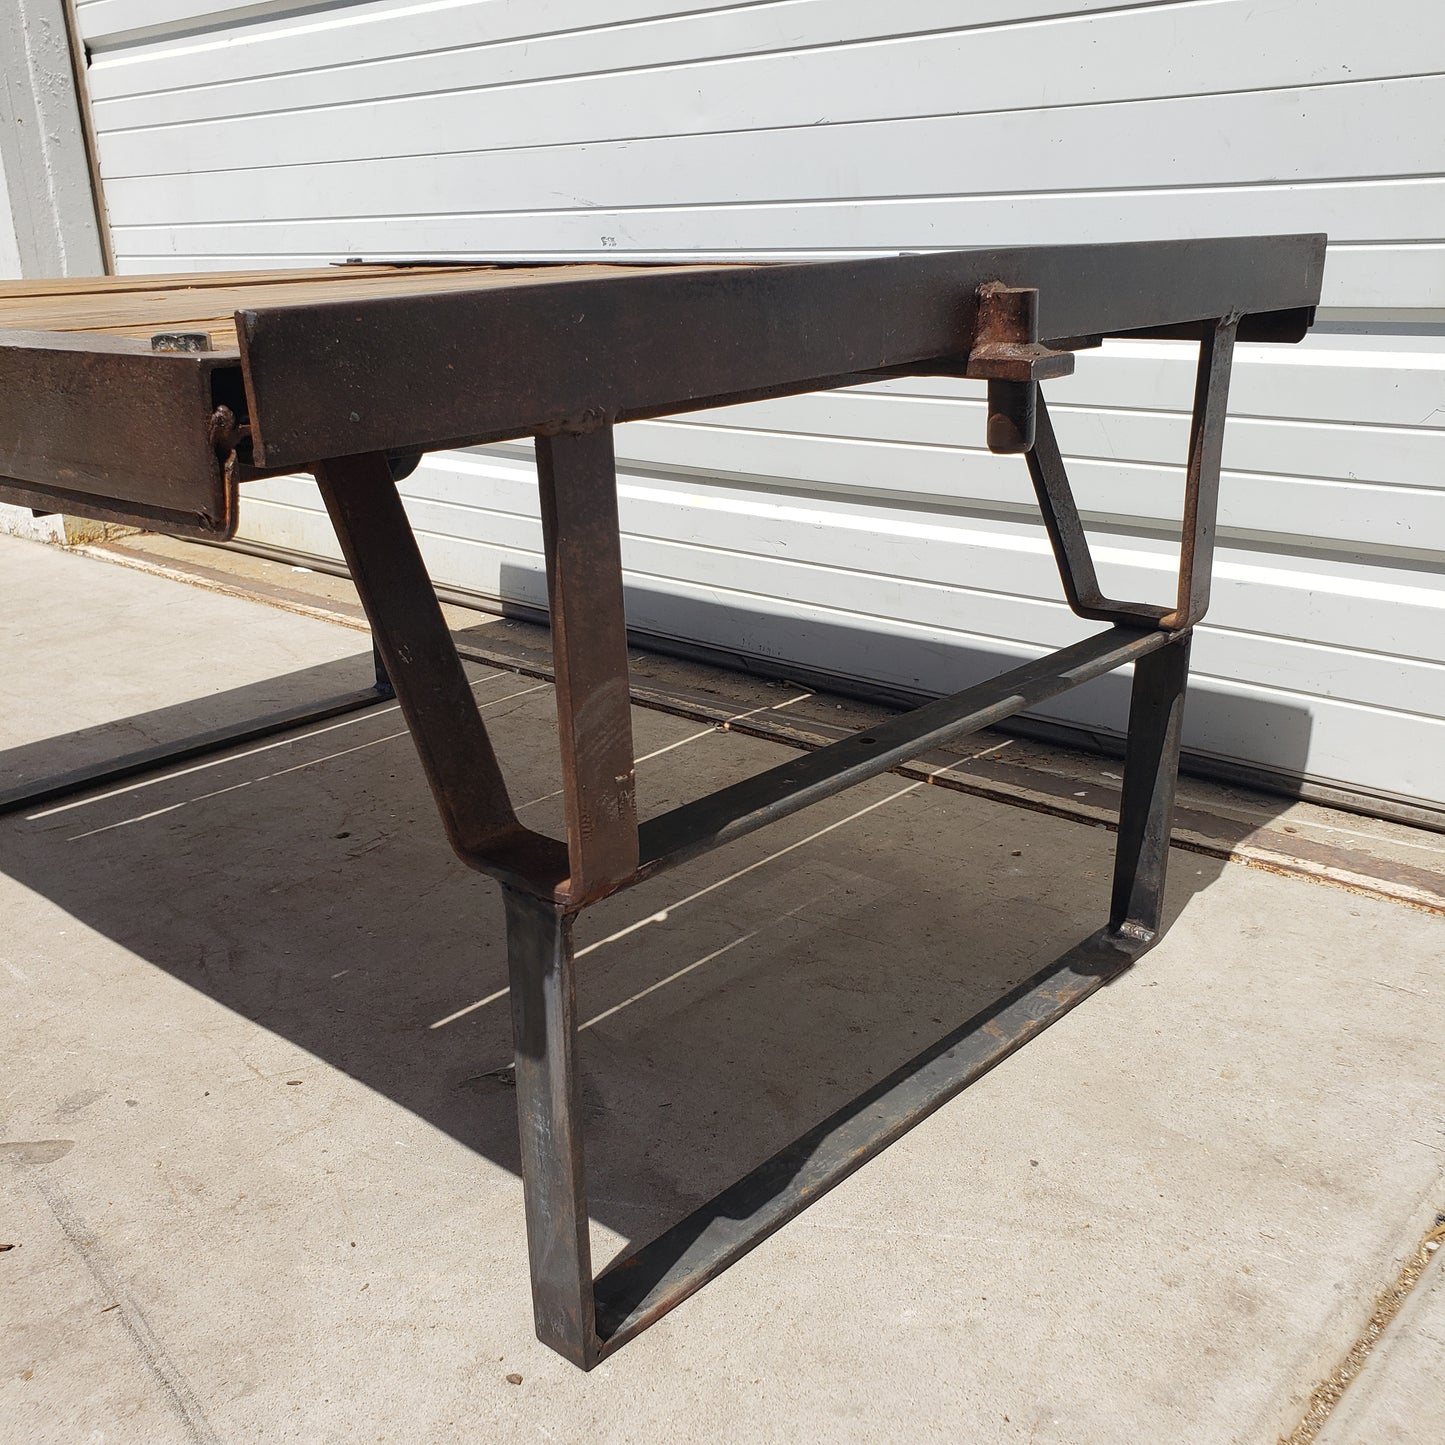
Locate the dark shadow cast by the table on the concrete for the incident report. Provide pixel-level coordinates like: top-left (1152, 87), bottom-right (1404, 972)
top-left (0, 644), bottom-right (1254, 1277)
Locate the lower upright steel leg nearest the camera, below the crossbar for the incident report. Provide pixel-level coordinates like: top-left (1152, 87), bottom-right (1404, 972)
top-left (503, 889), bottom-right (598, 1370)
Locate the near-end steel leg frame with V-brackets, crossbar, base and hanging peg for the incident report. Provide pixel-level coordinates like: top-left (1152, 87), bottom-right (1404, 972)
top-left (307, 299), bottom-right (1238, 1368)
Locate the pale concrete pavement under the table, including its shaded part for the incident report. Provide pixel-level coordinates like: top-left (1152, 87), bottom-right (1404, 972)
top-left (0, 539), bottom-right (1445, 1445)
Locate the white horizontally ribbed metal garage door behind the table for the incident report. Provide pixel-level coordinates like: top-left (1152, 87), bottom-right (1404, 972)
top-left (67, 0), bottom-right (1445, 808)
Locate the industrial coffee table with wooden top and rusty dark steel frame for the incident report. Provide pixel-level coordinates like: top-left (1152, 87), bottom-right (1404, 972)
top-left (0, 236), bottom-right (1325, 1368)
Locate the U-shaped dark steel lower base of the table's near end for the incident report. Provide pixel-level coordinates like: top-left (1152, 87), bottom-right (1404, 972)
top-left (506, 633), bottom-right (1191, 1368)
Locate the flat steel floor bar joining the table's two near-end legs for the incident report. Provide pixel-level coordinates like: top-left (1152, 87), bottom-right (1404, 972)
top-left (595, 928), bottom-right (1153, 1357)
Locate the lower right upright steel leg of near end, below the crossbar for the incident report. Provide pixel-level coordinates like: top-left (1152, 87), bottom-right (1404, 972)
top-left (1108, 633), bottom-right (1192, 946)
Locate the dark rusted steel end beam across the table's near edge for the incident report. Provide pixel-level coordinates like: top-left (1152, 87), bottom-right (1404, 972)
top-left (238, 236), bottom-right (1324, 468)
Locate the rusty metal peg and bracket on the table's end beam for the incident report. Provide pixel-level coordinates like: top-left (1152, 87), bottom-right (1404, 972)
top-left (964, 280), bottom-right (1074, 455)
